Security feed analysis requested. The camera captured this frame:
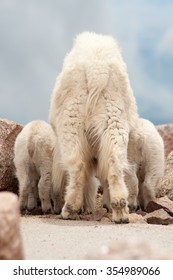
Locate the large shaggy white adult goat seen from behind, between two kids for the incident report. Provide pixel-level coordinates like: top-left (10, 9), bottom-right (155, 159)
top-left (49, 32), bottom-right (138, 222)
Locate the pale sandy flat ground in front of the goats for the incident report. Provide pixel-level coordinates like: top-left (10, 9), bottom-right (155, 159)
top-left (21, 215), bottom-right (173, 260)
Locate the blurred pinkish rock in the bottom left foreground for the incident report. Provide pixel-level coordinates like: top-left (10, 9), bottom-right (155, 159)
top-left (0, 192), bottom-right (24, 260)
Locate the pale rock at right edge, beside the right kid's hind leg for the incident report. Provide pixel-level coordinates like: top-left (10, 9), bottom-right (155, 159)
top-left (156, 151), bottom-right (173, 200)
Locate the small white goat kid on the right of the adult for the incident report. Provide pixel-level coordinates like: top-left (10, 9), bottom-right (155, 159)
top-left (126, 118), bottom-right (165, 210)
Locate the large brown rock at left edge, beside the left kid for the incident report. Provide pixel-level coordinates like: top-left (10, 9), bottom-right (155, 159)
top-left (0, 119), bottom-right (22, 194)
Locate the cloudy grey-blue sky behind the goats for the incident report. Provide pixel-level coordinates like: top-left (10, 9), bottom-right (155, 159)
top-left (0, 0), bottom-right (173, 124)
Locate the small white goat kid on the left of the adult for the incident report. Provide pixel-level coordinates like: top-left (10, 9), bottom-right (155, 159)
top-left (14, 120), bottom-right (56, 213)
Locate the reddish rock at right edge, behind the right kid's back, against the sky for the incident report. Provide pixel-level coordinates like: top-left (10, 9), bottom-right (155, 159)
top-left (156, 124), bottom-right (173, 157)
